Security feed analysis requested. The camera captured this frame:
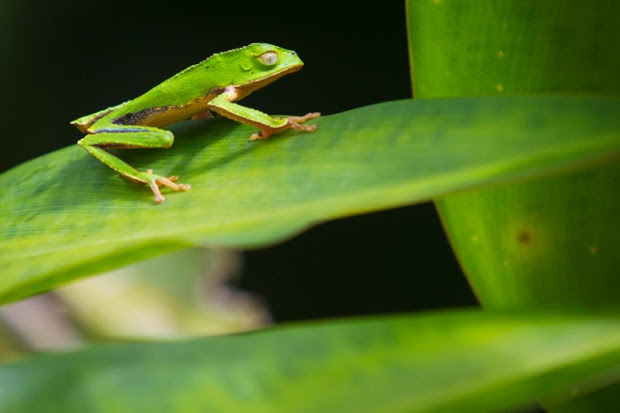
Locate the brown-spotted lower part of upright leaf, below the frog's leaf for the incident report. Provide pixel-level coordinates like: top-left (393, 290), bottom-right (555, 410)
top-left (439, 162), bottom-right (620, 310)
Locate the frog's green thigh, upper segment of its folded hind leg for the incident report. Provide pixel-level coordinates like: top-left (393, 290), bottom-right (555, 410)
top-left (78, 127), bottom-right (174, 149)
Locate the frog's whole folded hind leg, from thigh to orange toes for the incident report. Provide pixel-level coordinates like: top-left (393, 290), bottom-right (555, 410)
top-left (78, 126), bottom-right (191, 204)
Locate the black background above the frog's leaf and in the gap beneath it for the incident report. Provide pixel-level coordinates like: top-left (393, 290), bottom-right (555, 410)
top-left (0, 0), bottom-right (476, 321)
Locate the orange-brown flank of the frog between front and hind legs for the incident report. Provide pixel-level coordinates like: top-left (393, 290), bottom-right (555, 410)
top-left (112, 87), bottom-right (224, 127)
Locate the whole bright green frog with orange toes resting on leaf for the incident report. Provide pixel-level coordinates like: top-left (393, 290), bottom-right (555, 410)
top-left (71, 43), bottom-right (320, 204)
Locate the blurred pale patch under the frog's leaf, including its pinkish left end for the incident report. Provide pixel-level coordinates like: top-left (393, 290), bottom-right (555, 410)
top-left (0, 248), bottom-right (270, 351)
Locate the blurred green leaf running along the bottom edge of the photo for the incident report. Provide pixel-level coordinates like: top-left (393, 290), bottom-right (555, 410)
top-left (0, 310), bottom-right (620, 413)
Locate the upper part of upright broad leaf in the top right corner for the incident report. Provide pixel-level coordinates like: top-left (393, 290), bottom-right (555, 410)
top-left (407, 0), bottom-right (620, 98)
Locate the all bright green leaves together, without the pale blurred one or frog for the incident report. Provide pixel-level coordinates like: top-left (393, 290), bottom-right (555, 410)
top-left (0, 0), bottom-right (620, 411)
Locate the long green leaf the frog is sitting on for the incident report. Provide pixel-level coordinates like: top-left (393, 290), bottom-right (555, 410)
top-left (0, 97), bottom-right (620, 301)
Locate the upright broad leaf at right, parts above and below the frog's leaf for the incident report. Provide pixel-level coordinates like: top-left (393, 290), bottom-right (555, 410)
top-left (408, 0), bottom-right (620, 309)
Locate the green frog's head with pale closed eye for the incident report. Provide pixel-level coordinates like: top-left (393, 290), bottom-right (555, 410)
top-left (229, 43), bottom-right (304, 96)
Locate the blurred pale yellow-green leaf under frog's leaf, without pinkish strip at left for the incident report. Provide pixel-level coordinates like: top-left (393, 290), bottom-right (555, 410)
top-left (56, 248), bottom-right (269, 338)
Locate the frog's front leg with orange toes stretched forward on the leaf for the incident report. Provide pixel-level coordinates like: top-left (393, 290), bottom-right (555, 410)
top-left (208, 88), bottom-right (321, 141)
